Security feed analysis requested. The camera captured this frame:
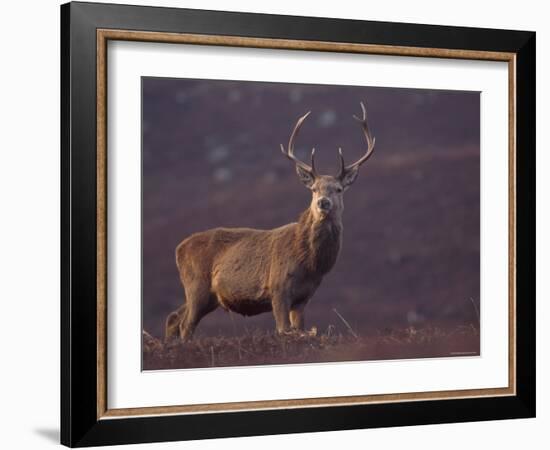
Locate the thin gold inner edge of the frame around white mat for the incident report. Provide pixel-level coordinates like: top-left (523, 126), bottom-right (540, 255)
top-left (96, 29), bottom-right (516, 420)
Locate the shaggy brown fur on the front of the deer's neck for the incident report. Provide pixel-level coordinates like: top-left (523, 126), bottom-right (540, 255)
top-left (296, 208), bottom-right (343, 276)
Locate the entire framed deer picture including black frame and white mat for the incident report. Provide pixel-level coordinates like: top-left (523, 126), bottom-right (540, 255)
top-left (61, 3), bottom-right (535, 447)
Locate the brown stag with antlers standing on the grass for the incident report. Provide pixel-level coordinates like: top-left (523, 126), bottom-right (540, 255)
top-left (165, 102), bottom-right (375, 341)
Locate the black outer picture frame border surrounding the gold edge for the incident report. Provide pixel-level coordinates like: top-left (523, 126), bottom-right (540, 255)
top-left (61, 2), bottom-right (536, 447)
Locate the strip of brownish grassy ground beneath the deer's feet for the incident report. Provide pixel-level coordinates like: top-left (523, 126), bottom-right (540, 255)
top-left (143, 325), bottom-right (480, 370)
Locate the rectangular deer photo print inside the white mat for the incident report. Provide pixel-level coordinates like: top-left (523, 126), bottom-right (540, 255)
top-left (142, 77), bottom-right (480, 370)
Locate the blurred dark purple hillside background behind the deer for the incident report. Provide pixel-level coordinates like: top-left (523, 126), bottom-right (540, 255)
top-left (142, 78), bottom-right (480, 337)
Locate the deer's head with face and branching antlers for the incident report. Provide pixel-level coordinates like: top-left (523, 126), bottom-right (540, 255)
top-left (281, 102), bottom-right (375, 220)
